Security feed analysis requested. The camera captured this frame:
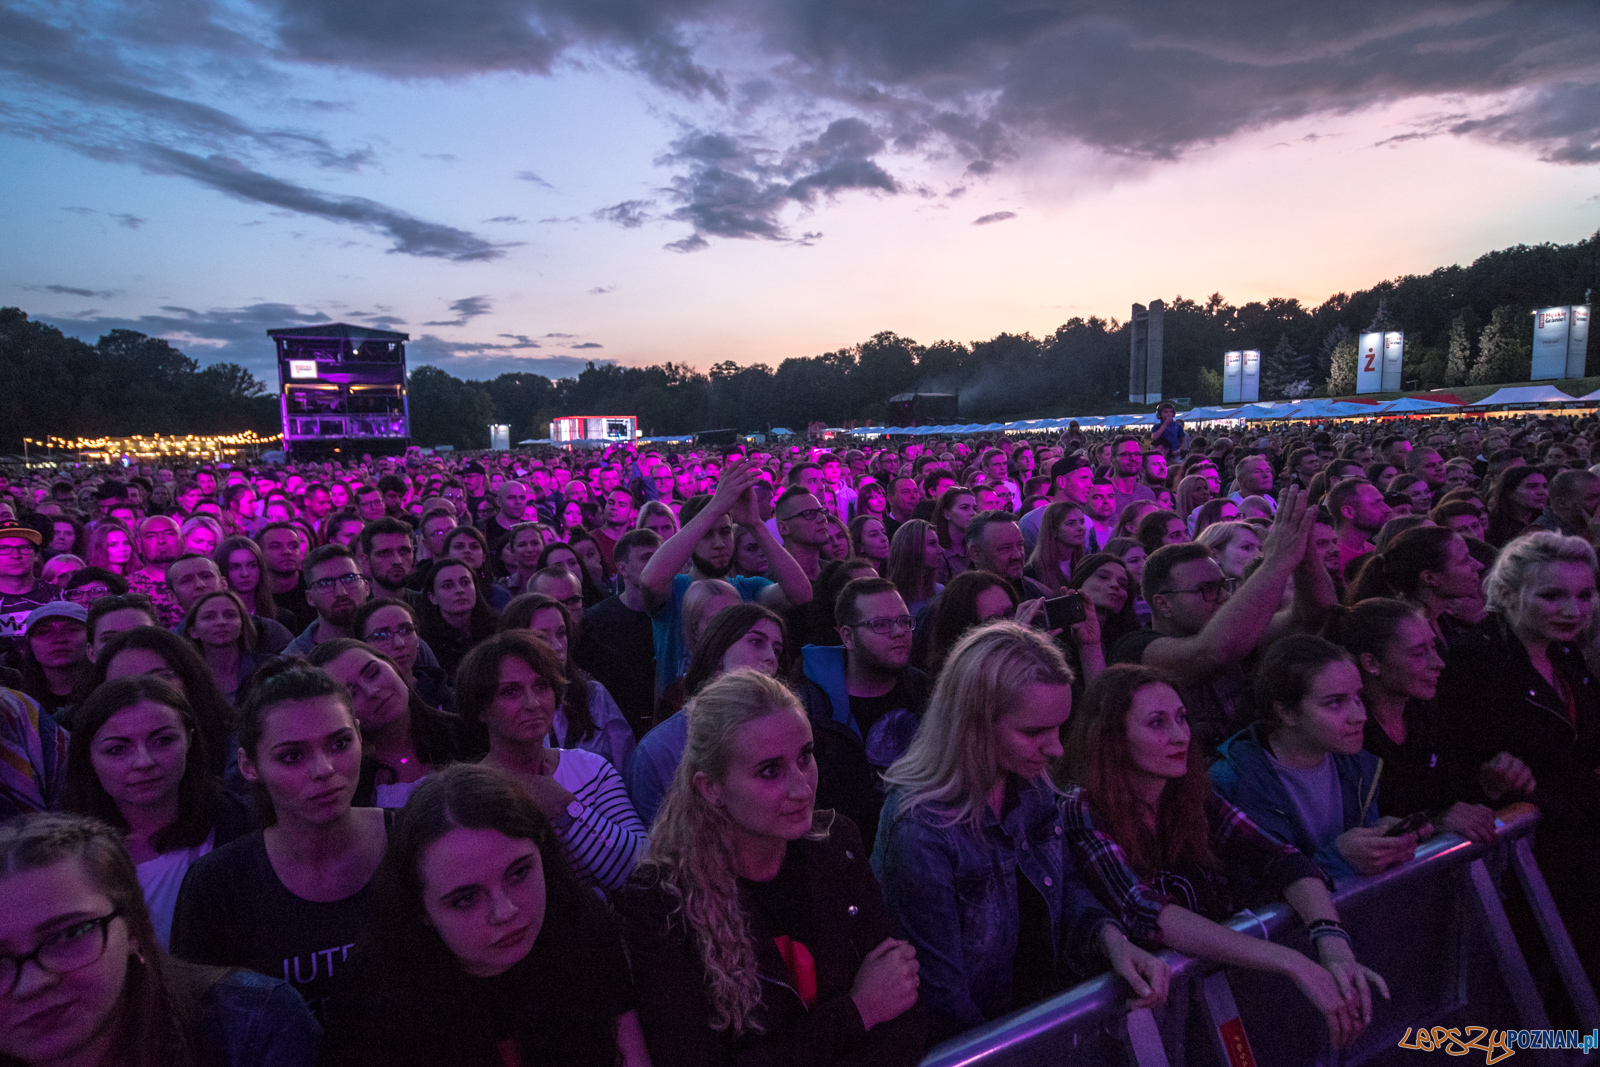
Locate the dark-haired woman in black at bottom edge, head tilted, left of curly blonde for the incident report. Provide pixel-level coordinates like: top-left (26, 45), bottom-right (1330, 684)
top-left (320, 765), bottom-right (650, 1067)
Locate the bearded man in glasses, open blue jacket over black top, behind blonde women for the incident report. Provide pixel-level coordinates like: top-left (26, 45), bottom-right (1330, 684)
top-left (797, 577), bottom-right (930, 837)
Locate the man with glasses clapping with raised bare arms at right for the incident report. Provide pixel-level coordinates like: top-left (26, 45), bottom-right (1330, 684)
top-left (1109, 488), bottom-right (1338, 760)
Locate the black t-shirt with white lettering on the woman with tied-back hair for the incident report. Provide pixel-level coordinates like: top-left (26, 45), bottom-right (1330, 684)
top-left (173, 830), bottom-right (373, 1021)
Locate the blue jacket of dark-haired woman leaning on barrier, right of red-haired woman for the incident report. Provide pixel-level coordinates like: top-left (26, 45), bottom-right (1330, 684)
top-left (1211, 723), bottom-right (1378, 885)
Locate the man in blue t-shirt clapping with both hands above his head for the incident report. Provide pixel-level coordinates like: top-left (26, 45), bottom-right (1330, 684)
top-left (640, 461), bottom-right (821, 694)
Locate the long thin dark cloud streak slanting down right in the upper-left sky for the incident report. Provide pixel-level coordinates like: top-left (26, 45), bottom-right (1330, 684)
top-left (142, 144), bottom-right (507, 262)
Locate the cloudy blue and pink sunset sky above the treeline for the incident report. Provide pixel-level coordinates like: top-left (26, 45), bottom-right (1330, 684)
top-left (0, 0), bottom-right (1600, 386)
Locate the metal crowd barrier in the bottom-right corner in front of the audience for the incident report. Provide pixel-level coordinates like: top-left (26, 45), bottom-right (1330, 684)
top-left (923, 805), bottom-right (1600, 1067)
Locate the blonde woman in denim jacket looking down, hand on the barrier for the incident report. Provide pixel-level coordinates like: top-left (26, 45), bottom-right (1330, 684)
top-left (870, 622), bottom-right (1168, 1041)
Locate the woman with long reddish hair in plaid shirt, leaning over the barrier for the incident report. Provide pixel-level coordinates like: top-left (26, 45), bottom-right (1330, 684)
top-left (1061, 664), bottom-right (1389, 1048)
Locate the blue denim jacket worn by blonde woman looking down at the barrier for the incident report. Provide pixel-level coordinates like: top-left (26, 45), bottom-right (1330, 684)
top-left (872, 777), bottom-right (1120, 1041)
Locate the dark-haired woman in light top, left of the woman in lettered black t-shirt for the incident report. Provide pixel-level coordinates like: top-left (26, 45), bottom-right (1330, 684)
top-left (61, 675), bottom-right (251, 949)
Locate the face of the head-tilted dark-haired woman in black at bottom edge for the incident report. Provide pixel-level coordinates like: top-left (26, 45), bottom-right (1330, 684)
top-left (416, 827), bottom-right (546, 977)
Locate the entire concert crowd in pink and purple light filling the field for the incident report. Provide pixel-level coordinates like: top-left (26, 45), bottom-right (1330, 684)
top-left (0, 403), bottom-right (1600, 1067)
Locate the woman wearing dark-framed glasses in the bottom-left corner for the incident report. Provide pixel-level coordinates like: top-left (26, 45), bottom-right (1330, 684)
top-left (0, 813), bottom-right (318, 1067)
